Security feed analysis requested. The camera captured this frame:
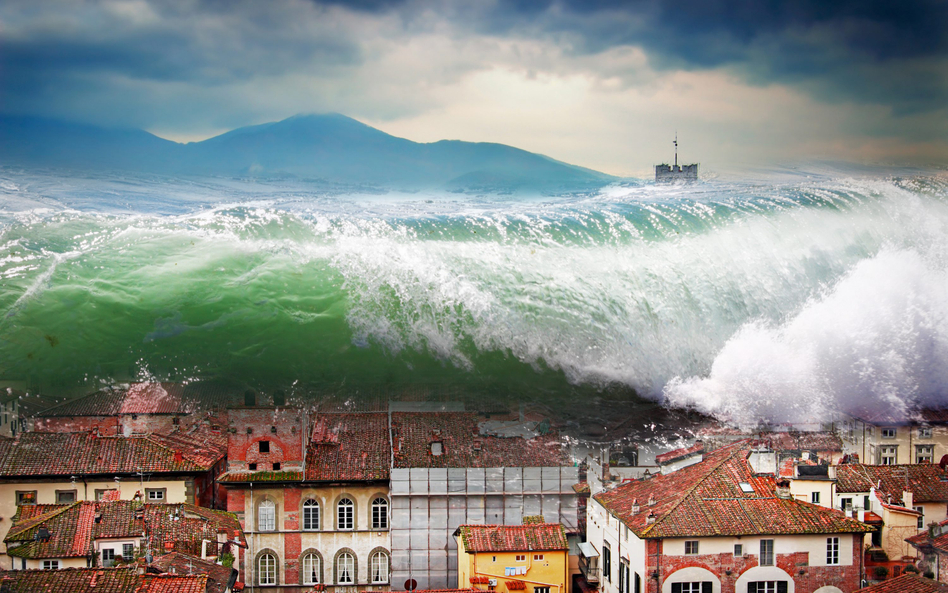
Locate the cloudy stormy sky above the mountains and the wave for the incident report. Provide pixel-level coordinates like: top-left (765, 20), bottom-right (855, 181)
top-left (0, 0), bottom-right (948, 175)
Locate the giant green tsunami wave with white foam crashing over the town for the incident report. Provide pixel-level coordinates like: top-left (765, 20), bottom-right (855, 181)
top-left (0, 170), bottom-right (948, 422)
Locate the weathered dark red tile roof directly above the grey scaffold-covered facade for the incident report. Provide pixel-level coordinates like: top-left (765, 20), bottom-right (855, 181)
top-left (392, 412), bottom-right (569, 468)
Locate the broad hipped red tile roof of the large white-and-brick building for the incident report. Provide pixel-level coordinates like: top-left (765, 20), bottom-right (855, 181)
top-left (593, 441), bottom-right (871, 538)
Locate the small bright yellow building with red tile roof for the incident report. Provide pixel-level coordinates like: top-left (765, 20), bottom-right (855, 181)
top-left (454, 517), bottom-right (569, 593)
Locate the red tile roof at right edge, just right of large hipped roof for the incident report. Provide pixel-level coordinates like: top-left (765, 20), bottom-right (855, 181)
top-left (836, 463), bottom-right (948, 503)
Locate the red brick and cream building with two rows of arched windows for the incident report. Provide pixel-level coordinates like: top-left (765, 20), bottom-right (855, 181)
top-left (221, 407), bottom-right (391, 591)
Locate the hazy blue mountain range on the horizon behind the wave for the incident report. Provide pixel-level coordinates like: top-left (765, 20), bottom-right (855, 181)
top-left (0, 114), bottom-right (613, 191)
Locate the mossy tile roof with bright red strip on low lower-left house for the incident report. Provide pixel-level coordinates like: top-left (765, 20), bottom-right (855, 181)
top-left (3, 500), bottom-right (244, 558)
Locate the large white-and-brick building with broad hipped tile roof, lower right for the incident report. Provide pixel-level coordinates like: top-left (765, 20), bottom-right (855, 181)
top-left (586, 442), bottom-right (871, 593)
